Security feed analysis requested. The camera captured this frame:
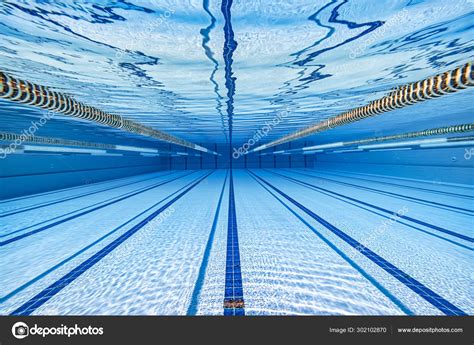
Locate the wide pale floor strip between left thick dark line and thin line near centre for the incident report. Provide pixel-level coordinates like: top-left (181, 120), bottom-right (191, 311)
top-left (11, 171), bottom-right (225, 315)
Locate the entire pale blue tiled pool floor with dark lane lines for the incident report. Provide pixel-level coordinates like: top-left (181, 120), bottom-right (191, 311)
top-left (0, 169), bottom-right (474, 315)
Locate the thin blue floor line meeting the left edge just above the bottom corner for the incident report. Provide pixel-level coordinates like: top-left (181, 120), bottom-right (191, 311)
top-left (0, 171), bottom-right (209, 304)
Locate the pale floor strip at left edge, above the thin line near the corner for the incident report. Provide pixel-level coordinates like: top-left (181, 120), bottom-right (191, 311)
top-left (0, 171), bottom-right (205, 310)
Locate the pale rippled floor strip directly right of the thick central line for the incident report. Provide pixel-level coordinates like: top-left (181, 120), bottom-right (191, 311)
top-left (234, 170), bottom-right (404, 315)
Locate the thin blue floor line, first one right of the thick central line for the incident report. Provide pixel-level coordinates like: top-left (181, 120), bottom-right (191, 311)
top-left (247, 171), bottom-right (414, 315)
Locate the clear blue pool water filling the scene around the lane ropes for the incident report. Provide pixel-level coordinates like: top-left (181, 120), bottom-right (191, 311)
top-left (0, 0), bottom-right (474, 315)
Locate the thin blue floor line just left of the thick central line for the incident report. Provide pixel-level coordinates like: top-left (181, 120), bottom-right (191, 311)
top-left (186, 170), bottom-right (229, 315)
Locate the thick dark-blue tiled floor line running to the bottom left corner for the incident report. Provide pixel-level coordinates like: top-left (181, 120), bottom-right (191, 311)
top-left (10, 172), bottom-right (213, 316)
